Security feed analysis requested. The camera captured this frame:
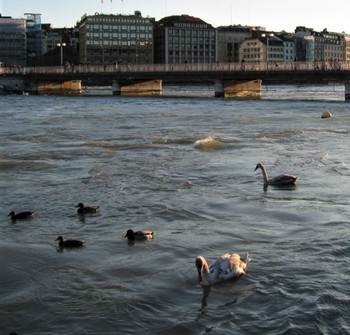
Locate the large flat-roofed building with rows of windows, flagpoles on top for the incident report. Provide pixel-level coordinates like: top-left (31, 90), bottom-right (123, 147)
top-left (78, 11), bottom-right (154, 65)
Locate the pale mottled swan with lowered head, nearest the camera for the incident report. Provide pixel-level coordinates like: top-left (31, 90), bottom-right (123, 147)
top-left (195, 253), bottom-right (251, 287)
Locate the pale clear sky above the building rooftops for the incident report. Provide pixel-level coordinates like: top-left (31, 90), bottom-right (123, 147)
top-left (0, 0), bottom-right (350, 34)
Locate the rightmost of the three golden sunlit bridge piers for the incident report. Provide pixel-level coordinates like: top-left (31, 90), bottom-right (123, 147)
top-left (214, 79), bottom-right (261, 99)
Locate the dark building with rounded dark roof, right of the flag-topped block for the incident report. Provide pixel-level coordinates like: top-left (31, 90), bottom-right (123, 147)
top-left (154, 15), bottom-right (218, 64)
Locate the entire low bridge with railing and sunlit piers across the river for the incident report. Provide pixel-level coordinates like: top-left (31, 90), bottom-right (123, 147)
top-left (0, 61), bottom-right (350, 100)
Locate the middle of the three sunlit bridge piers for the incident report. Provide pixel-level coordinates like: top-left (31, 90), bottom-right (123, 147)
top-left (112, 80), bottom-right (162, 96)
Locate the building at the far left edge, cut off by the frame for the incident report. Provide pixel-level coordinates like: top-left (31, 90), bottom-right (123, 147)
top-left (0, 15), bottom-right (27, 66)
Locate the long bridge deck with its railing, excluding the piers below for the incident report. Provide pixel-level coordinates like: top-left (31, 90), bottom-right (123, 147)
top-left (0, 62), bottom-right (350, 85)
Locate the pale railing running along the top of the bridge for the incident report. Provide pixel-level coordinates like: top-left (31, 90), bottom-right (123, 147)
top-left (0, 61), bottom-right (350, 75)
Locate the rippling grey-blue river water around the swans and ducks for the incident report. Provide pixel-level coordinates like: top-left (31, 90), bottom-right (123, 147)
top-left (0, 86), bottom-right (350, 335)
